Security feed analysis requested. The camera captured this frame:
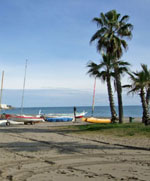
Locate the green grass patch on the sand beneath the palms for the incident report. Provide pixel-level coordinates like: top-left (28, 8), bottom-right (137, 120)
top-left (65, 123), bottom-right (150, 137)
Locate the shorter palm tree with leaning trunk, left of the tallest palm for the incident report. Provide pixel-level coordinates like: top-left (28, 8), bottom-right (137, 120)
top-left (87, 55), bottom-right (117, 122)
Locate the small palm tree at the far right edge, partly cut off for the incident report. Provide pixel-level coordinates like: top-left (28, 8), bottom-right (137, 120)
top-left (124, 65), bottom-right (150, 125)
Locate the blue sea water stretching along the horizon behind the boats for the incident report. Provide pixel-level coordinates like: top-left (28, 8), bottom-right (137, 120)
top-left (1, 106), bottom-right (142, 117)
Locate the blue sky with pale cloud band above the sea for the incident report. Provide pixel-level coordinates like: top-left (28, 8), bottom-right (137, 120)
top-left (0, 0), bottom-right (150, 107)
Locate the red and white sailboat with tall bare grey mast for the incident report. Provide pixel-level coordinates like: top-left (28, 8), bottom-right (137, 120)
top-left (4, 60), bottom-right (45, 125)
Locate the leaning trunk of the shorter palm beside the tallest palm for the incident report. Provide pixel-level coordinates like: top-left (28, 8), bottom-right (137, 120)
top-left (107, 77), bottom-right (117, 123)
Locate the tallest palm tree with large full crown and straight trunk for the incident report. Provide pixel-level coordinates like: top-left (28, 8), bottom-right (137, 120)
top-left (90, 10), bottom-right (133, 123)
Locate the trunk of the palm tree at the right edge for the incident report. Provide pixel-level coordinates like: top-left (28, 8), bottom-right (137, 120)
top-left (140, 89), bottom-right (149, 125)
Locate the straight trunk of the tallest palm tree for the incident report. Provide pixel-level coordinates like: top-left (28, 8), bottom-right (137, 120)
top-left (115, 67), bottom-right (123, 123)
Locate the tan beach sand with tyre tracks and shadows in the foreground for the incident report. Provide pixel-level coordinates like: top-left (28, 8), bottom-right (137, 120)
top-left (0, 118), bottom-right (150, 181)
